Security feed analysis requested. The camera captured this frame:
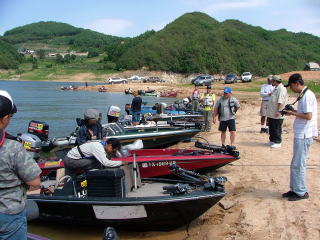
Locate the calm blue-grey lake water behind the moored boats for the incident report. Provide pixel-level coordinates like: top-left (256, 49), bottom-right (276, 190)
top-left (0, 81), bottom-right (174, 137)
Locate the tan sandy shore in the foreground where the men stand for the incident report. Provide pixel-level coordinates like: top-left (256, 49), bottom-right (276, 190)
top-left (120, 94), bottom-right (320, 240)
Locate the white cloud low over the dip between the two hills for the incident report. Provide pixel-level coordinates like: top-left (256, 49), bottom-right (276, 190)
top-left (85, 18), bottom-right (133, 35)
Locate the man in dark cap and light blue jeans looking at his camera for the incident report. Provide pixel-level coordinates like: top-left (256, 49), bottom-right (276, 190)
top-left (282, 73), bottom-right (318, 201)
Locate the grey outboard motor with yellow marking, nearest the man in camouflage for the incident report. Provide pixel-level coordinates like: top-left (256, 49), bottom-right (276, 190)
top-left (18, 133), bottom-right (42, 160)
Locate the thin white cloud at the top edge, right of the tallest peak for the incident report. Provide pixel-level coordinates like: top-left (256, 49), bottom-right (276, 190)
top-left (202, 0), bottom-right (268, 14)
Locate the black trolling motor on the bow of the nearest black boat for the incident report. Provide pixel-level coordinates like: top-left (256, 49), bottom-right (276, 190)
top-left (163, 164), bottom-right (227, 195)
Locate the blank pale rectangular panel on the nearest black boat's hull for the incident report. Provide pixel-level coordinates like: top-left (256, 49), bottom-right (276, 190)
top-left (92, 205), bottom-right (147, 219)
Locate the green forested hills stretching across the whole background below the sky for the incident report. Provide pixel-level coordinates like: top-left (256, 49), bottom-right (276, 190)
top-left (2, 12), bottom-right (320, 75)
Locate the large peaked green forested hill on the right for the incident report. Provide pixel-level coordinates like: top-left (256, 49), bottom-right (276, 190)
top-left (117, 12), bottom-right (320, 75)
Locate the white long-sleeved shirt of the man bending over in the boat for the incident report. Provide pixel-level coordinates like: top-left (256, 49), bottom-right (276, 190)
top-left (67, 141), bottom-right (122, 167)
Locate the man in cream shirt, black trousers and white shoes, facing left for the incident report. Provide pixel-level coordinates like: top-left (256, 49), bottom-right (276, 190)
top-left (267, 75), bottom-right (288, 148)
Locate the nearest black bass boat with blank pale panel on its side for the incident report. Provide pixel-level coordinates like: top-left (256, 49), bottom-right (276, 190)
top-left (28, 165), bottom-right (226, 231)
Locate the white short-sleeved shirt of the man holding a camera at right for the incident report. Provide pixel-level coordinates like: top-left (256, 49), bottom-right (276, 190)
top-left (293, 87), bottom-right (318, 138)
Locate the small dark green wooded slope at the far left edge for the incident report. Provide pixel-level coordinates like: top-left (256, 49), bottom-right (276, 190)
top-left (0, 39), bottom-right (22, 69)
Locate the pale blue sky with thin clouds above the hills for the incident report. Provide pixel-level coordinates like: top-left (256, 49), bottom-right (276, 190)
top-left (0, 0), bottom-right (320, 37)
